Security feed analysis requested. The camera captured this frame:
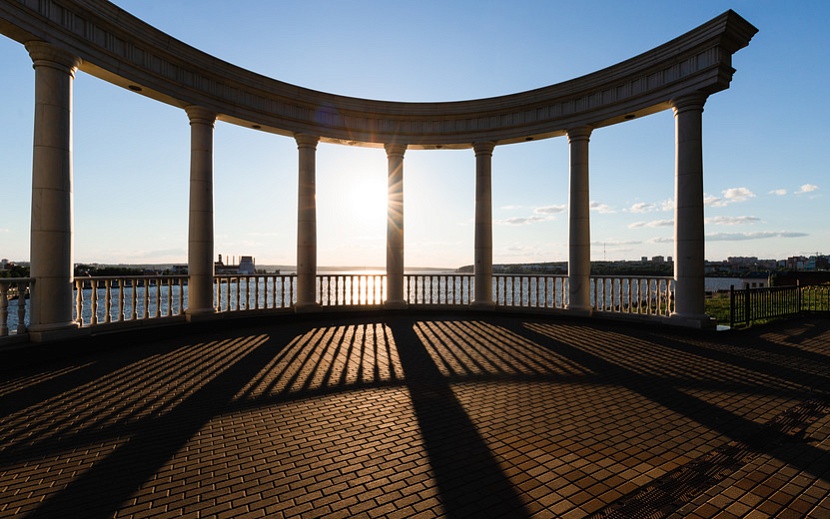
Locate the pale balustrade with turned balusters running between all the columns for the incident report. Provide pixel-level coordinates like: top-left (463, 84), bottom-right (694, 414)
top-left (8, 273), bottom-right (674, 337)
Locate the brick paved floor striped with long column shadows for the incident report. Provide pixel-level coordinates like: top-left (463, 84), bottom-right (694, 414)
top-left (0, 316), bottom-right (830, 518)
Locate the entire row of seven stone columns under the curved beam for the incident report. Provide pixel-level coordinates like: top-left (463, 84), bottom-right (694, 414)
top-left (26, 41), bottom-right (710, 340)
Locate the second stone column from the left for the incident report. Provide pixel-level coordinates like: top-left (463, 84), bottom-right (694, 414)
top-left (185, 105), bottom-right (216, 320)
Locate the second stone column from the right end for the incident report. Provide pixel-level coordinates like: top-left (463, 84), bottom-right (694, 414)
top-left (567, 126), bottom-right (591, 315)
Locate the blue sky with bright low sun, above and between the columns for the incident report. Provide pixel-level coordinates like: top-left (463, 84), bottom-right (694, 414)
top-left (0, 0), bottom-right (830, 267)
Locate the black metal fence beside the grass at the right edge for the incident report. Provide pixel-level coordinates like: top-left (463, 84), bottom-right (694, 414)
top-left (729, 284), bottom-right (830, 328)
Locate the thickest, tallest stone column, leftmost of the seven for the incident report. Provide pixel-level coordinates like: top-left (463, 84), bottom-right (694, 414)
top-left (26, 41), bottom-right (81, 341)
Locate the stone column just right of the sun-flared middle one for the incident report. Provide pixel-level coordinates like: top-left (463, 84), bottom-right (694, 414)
top-left (473, 142), bottom-right (496, 308)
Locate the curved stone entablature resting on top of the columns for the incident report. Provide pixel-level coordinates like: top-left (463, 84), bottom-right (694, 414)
top-left (0, 0), bottom-right (757, 148)
